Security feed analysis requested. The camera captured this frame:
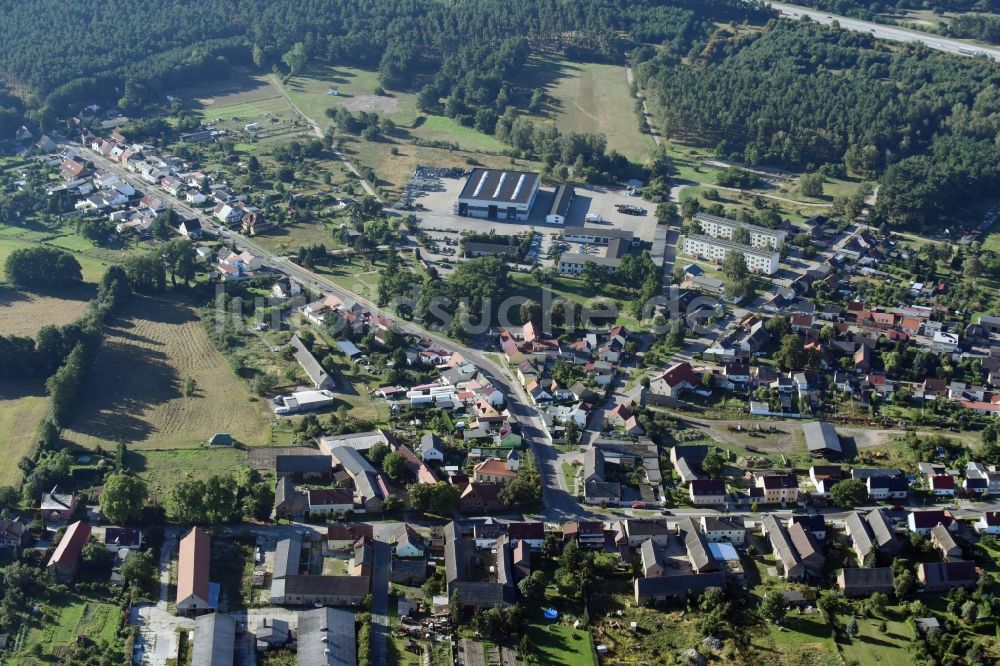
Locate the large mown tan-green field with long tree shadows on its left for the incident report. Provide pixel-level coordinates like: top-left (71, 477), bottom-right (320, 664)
top-left (64, 296), bottom-right (268, 450)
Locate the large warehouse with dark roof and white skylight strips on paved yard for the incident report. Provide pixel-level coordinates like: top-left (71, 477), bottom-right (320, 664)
top-left (455, 169), bottom-right (540, 222)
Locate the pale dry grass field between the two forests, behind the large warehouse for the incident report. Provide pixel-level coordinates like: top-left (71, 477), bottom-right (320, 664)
top-left (522, 59), bottom-right (656, 164)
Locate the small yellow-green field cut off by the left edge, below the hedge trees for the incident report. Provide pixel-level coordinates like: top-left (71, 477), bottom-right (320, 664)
top-left (0, 380), bottom-right (49, 486)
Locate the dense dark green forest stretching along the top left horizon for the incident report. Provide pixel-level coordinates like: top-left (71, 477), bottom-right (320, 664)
top-left (0, 0), bottom-right (763, 125)
